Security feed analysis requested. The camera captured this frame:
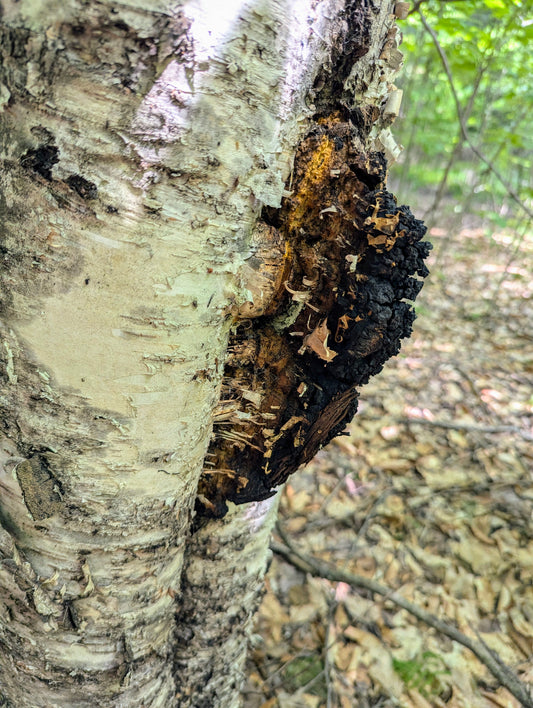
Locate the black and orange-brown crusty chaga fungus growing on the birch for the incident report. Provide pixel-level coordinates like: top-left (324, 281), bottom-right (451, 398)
top-left (198, 116), bottom-right (431, 516)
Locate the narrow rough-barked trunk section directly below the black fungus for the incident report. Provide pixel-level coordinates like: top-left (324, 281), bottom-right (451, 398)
top-left (175, 494), bottom-right (279, 708)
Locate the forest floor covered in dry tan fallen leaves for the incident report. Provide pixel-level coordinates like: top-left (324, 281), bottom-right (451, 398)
top-left (244, 217), bottom-right (533, 708)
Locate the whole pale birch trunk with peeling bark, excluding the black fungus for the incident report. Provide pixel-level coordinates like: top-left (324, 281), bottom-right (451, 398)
top-left (0, 0), bottom-right (414, 708)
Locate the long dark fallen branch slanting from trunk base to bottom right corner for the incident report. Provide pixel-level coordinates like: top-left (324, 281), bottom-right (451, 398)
top-left (270, 524), bottom-right (533, 708)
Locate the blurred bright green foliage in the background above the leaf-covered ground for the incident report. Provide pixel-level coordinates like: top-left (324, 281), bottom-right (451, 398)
top-left (391, 0), bottom-right (533, 224)
